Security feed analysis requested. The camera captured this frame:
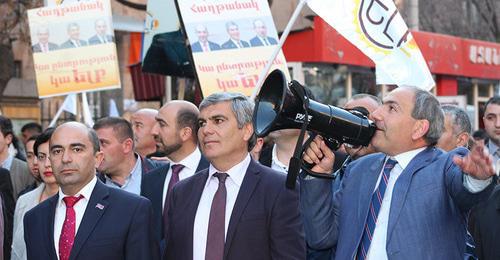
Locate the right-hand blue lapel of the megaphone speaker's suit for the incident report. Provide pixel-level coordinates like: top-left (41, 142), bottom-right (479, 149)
top-left (387, 148), bottom-right (435, 241)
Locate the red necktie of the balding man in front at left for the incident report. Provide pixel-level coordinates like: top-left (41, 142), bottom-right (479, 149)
top-left (59, 195), bottom-right (83, 260)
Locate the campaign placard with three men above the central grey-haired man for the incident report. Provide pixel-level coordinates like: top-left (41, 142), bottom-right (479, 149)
top-left (178, 0), bottom-right (289, 96)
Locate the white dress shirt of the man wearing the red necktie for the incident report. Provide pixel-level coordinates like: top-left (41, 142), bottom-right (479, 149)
top-left (54, 176), bottom-right (97, 259)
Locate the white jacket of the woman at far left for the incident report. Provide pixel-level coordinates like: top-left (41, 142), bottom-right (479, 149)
top-left (10, 183), bottom-right (45, 260)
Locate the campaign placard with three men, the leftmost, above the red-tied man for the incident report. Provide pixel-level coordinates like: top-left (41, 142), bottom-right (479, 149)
top-left (28, 0), bottom-right (120, 98)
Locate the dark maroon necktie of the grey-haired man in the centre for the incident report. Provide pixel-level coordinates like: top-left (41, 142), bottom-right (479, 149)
top-left (205, 172), bottom-right (228, 260)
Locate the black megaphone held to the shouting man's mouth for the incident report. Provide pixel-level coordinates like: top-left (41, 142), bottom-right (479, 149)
top-left (253, 69), bottom-right (376, 146)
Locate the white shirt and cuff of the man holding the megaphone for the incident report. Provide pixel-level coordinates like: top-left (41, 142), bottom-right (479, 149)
top-left (366, 147), bottom-right (492, 260)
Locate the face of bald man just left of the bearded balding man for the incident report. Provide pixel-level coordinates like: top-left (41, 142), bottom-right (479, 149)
top-left (130, 108), bottom-right (158, 157)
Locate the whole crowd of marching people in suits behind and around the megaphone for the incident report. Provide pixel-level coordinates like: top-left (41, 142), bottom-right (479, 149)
top-left (0, 87), bottom-right (500, 260)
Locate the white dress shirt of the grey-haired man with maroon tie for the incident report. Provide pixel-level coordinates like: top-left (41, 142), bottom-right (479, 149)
top-left (193, 154), bottom-right (251, 260)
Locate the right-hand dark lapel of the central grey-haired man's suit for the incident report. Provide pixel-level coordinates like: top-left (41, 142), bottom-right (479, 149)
top-left (224, 160), bottom-right (261, 257)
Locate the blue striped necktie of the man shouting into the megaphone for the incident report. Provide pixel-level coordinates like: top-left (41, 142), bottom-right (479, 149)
top-left (357, 159), bottom-right (398, 260)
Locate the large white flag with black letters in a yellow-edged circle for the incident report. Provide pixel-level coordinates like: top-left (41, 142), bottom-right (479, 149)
top-left (307, 0), bottom-right (435, 90)
